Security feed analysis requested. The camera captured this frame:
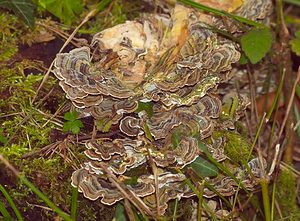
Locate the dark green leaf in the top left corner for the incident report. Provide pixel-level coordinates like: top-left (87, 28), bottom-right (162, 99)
top-left (0, 0), bottom-right (35, 27)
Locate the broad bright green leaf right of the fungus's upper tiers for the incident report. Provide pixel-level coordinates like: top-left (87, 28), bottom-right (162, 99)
top-left (241, 28), bottom-right (272, 64)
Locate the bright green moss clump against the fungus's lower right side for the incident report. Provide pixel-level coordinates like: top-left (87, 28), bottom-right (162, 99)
top-left (212, 130), bottom-right (250, 165)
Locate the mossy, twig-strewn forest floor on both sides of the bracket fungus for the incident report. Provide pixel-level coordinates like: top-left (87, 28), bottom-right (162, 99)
top-left (0, 0), bottom-right (300, 220)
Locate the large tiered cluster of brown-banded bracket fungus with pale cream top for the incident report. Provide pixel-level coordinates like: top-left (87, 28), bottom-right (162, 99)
top-left (54, 0), bottom-right (271, 215)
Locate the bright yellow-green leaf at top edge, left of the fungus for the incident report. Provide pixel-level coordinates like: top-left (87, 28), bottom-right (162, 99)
top-left (39, 0), bottom-right (83, 25)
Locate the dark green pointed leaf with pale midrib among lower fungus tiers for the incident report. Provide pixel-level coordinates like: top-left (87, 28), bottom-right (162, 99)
top-left (187, 157), bottom-right (219, 177)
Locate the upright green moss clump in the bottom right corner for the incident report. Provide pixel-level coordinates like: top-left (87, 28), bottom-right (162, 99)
top-left (275, 170), bottom-right (300, 221)
